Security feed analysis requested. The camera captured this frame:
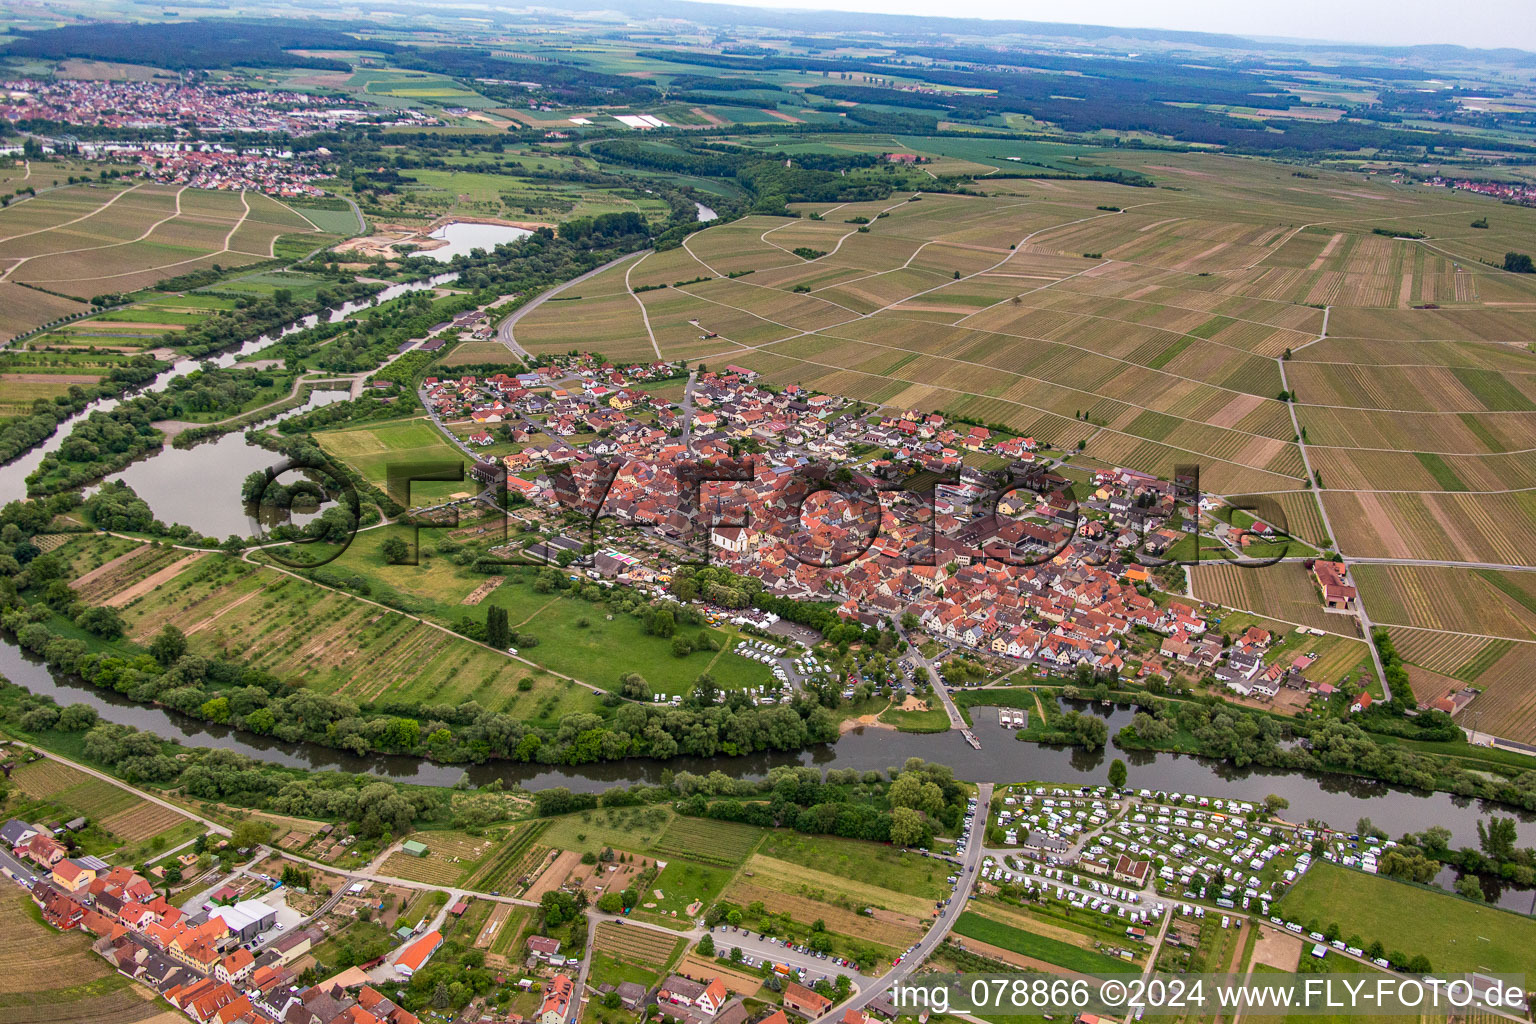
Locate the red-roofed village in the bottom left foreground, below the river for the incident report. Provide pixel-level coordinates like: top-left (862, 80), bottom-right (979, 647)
top-left (0, 798), bottom-right (895, 1024)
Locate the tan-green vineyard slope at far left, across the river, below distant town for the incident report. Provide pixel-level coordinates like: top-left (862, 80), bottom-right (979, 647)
top-left (0, 181), bottom-right (333, 338)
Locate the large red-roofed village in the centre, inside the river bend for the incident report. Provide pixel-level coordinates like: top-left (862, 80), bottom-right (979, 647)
top-left (421, 356), bottom-right (1372, 724)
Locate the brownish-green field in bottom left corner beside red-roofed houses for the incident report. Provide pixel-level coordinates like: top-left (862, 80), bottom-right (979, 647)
top-left (0, 887), bottom-right (184, 1024)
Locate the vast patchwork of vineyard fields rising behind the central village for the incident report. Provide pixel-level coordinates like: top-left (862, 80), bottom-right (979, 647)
top-left (516, 137), bottom-right (1536, 543)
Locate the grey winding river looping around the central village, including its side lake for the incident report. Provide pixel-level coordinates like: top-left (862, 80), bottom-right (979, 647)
top-left (0, 264), bottom-right (1536, 872)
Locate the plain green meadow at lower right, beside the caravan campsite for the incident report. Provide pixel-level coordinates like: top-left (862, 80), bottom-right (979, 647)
top-left (1279, 863), bottom-right (1536, 972)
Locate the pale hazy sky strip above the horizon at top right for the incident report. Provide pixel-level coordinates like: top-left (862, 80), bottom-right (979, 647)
top-left (749, 0), bottom-right (1536, 51)
